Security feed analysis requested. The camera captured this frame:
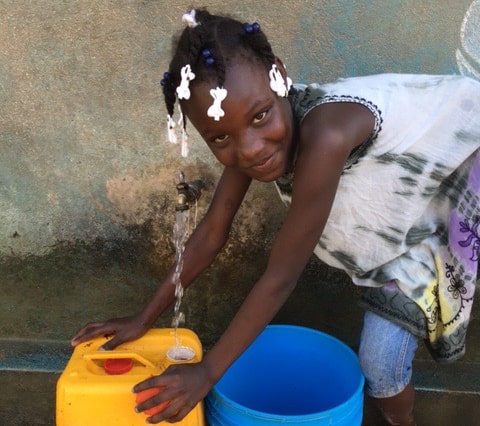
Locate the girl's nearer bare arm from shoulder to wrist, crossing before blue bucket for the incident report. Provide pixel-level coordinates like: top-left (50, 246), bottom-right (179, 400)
top-left (204, 103), bottom-right (374, 383)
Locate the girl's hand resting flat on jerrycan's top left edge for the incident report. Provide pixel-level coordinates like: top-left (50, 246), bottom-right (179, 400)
top-left (71, 314), bottom-right (150, 351)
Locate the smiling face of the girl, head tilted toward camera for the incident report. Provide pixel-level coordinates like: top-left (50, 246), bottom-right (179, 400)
top-left (182, 60), bottom-right (293, 182)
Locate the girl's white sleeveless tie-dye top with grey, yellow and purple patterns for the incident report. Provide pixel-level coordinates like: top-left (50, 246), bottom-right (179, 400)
top-left (276, 74), bottom-right (480, 361)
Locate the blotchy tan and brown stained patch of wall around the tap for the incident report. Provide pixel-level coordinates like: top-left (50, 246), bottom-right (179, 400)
top-left (99, 161), bottom-right (282, 258)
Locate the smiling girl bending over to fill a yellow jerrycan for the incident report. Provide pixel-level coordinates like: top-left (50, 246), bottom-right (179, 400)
top-left (72, 10), bottom-right (480, 425)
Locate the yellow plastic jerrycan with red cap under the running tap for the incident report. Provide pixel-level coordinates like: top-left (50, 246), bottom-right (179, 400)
top-left (56, 328), bottom-right (206, 426)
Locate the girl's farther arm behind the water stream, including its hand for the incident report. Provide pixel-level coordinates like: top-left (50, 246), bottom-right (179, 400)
top-left (72, 168), bottom-right (251, 350)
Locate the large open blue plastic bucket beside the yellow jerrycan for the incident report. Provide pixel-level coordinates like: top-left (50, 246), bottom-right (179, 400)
top-left (205, 325), bottom-right (364, 426)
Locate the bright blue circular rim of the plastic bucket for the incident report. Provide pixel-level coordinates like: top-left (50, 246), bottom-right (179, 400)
top-left (206, 324), bottom-right (365, 423)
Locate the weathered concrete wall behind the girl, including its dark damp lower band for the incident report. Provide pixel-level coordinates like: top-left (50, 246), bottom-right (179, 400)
top-left (0, 0), bottom-right (480, 344)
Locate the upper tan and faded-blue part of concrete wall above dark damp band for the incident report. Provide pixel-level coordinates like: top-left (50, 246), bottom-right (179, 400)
top-left (0, 0), bottom-right (480, 259)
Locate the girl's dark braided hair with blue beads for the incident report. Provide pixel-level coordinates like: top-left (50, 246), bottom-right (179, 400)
top-left (162, 9), bottom-right (275, 129)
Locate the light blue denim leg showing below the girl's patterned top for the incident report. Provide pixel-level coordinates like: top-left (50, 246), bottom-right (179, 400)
top-left (358, 311), bottom-right (418, 398)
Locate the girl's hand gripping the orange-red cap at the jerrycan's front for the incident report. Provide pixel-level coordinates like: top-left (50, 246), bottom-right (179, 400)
top-left (133, 362), bottom-right (213, 423)
